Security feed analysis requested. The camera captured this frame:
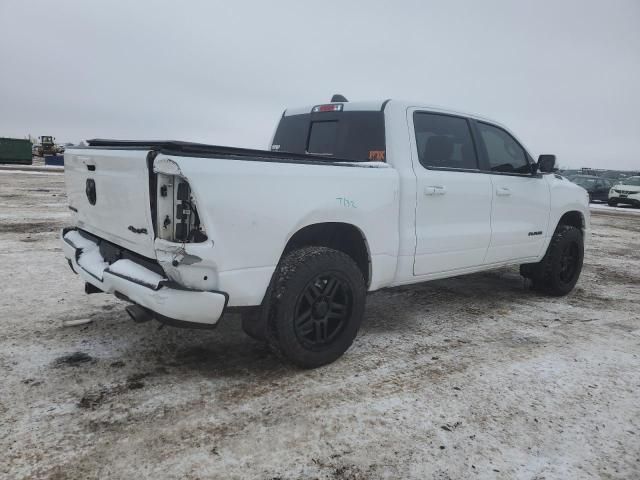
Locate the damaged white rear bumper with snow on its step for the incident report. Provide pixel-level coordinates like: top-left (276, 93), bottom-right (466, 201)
top-left (61, 229), bottom-right (229, 327)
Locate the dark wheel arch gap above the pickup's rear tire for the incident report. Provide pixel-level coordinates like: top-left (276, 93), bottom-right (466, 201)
top-left (280, 222), bottom-right (371, 287)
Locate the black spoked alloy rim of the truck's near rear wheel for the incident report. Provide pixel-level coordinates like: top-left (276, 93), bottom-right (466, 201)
top-left (294, 272), bottom-right (353, 350)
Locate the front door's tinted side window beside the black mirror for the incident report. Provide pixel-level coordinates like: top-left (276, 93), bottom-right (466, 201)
top-left (477, 122), bottom-right (531, 174)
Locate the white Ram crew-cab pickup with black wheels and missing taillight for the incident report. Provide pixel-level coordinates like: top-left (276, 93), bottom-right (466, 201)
top-left (62, 97), bottom-right (589, 368)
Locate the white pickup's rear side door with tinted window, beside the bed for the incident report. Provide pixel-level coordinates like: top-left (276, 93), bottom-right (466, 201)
top-left (408, 109), bottom-right (492, 276)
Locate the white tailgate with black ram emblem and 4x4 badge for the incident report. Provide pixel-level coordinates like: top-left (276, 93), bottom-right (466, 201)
top-left (64, 149), bottom-right (156, 258)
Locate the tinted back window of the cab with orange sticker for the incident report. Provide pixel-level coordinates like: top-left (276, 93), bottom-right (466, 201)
top-left (271, 110), bottom-right (386, 162)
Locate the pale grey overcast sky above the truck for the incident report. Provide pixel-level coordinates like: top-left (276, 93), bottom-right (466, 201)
top-left (0, 0), bottom-right (640, 169)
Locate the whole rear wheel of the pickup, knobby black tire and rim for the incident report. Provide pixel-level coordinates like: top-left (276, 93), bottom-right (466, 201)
top-left (266, 247), bottom-right (366, 368)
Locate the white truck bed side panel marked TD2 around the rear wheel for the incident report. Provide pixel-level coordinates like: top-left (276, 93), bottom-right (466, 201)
top-left (162, 155), bottom-right (399, 306)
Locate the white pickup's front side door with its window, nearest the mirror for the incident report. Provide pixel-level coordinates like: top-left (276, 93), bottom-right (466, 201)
top-left (474, 121), bottom-right (553, 264)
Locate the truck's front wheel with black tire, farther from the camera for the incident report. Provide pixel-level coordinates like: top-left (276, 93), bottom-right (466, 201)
top-left (520, 225), bottom-right (584, 297)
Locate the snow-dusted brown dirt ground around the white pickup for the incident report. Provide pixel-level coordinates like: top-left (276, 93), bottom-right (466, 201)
top-left (0, 173), bottom-right (640, 480)
